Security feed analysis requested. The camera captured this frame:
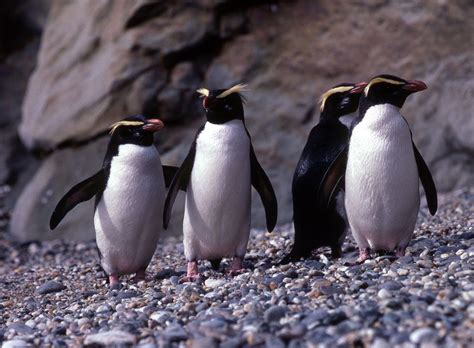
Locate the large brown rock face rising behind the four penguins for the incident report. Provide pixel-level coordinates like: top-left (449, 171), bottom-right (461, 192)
top-left (12, 0), bottom-right (474, 239)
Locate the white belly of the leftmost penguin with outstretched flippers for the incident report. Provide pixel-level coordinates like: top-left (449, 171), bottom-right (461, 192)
top-left (94, 144), bottom-right (165, 275)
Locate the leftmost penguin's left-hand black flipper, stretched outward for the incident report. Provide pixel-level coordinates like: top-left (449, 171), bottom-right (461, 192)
top-left (49, 169), bottom-right (106, 230)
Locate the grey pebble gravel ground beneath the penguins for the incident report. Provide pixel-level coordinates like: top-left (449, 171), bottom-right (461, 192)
top-left (0, 188), bottom-right (474, 348)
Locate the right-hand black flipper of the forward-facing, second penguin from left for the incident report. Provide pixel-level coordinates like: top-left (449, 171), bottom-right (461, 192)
top-left (250, 146), bottom-right (278, 232)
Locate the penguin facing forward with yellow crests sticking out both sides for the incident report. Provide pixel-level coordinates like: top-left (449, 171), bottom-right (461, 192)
top-left (163, 84), bottom-right (278, 281)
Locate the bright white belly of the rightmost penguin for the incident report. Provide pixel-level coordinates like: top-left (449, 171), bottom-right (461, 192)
top-left (345, 104), bottom-right (420, 250)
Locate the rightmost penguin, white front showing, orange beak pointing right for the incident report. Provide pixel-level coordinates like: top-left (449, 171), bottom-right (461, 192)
top-left (322, 75), bottom-right (438, 262)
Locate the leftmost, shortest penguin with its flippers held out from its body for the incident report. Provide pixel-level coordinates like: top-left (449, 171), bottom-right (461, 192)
top-left (50, 116), bottom-right (177, 288)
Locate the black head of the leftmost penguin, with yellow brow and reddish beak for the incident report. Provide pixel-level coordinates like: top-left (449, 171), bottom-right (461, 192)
top-left (110, 115), bottom-right (164, 146)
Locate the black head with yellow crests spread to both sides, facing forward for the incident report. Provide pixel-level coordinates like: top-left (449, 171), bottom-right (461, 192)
top-left (197, 84), bottom-right (245, 124)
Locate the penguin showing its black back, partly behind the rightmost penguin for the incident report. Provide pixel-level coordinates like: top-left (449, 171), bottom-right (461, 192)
top-left (282, 82), bottom-right (367, 263)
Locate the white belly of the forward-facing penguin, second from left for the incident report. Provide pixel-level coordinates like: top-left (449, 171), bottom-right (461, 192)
top-left (183, 120), bottom-right (251, 260)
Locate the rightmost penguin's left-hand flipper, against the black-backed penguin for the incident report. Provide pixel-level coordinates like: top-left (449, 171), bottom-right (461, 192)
top-left (317, 146), bottom-right (349, 208)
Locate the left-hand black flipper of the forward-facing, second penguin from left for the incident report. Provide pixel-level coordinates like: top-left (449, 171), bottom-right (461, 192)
top-left (163, 126), bottom-right (204, 229)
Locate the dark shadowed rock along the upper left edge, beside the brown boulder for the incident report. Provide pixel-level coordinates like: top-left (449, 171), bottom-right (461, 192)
top-left (0, 0), bottom-right (49, 184)
